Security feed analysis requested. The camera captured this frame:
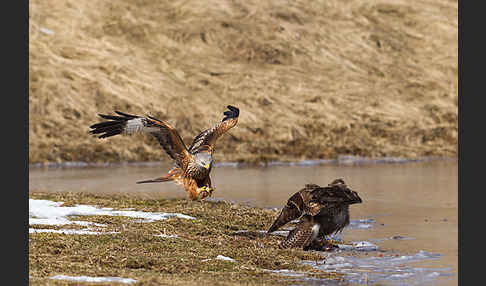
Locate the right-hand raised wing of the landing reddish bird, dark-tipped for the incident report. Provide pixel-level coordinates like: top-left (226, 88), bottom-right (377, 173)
top-left (189, 105), bottom-right (240, 153)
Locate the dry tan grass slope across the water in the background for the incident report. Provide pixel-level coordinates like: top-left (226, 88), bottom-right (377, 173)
top-left (29, 0), bottom-right (458, 163)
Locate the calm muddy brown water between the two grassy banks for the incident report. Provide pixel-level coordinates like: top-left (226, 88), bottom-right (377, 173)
top-left (29, 160), bottom-right (458, 285)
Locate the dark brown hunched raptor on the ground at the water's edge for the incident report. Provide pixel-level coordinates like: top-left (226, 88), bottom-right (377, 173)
top-left (267, 179), bottom-right (362, 250)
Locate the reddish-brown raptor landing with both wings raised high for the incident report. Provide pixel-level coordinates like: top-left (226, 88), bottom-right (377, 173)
top-left (90, 105), bottom-right (240, 200)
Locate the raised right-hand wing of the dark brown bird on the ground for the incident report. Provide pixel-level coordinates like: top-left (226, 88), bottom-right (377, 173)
top-left (312, 179), bottom-right (362, 205)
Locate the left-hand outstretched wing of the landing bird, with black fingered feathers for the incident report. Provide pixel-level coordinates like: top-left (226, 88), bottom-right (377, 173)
top-left (90, 111), bottom-right (190, 167)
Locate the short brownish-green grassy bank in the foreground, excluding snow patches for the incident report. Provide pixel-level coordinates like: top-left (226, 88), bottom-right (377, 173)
top-left (29, 192), bottom-right (346, 285)
